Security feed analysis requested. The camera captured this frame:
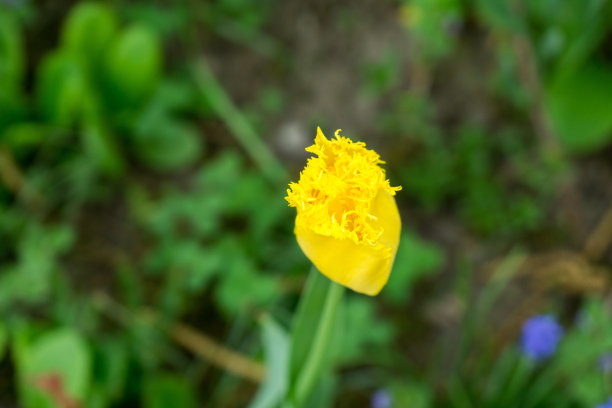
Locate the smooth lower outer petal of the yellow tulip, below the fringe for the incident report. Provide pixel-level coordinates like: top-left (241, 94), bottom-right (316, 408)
top-left (295, 190), bottom-right (401, 296)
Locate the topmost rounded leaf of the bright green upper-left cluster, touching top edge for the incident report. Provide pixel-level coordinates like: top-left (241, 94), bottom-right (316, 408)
top-left (62, 1), bottom-right (117, 64)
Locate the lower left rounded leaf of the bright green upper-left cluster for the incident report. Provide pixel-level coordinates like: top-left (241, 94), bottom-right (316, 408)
top-left (36, 52), bottom-right (90, 125)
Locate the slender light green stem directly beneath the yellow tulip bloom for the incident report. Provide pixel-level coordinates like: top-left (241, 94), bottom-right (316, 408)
top-left (295, 278), bottom-right (344, 406)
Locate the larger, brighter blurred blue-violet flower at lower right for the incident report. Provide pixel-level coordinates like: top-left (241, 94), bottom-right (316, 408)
top-left (520, 315), bottom-right (563, 360)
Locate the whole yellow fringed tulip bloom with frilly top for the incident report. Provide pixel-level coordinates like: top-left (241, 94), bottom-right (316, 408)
top-left (286, 128), bottom-right (401, 296)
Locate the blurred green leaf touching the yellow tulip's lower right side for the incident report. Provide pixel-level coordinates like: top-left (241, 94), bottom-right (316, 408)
top-left (382, 231), bottom-right (444, 303)
